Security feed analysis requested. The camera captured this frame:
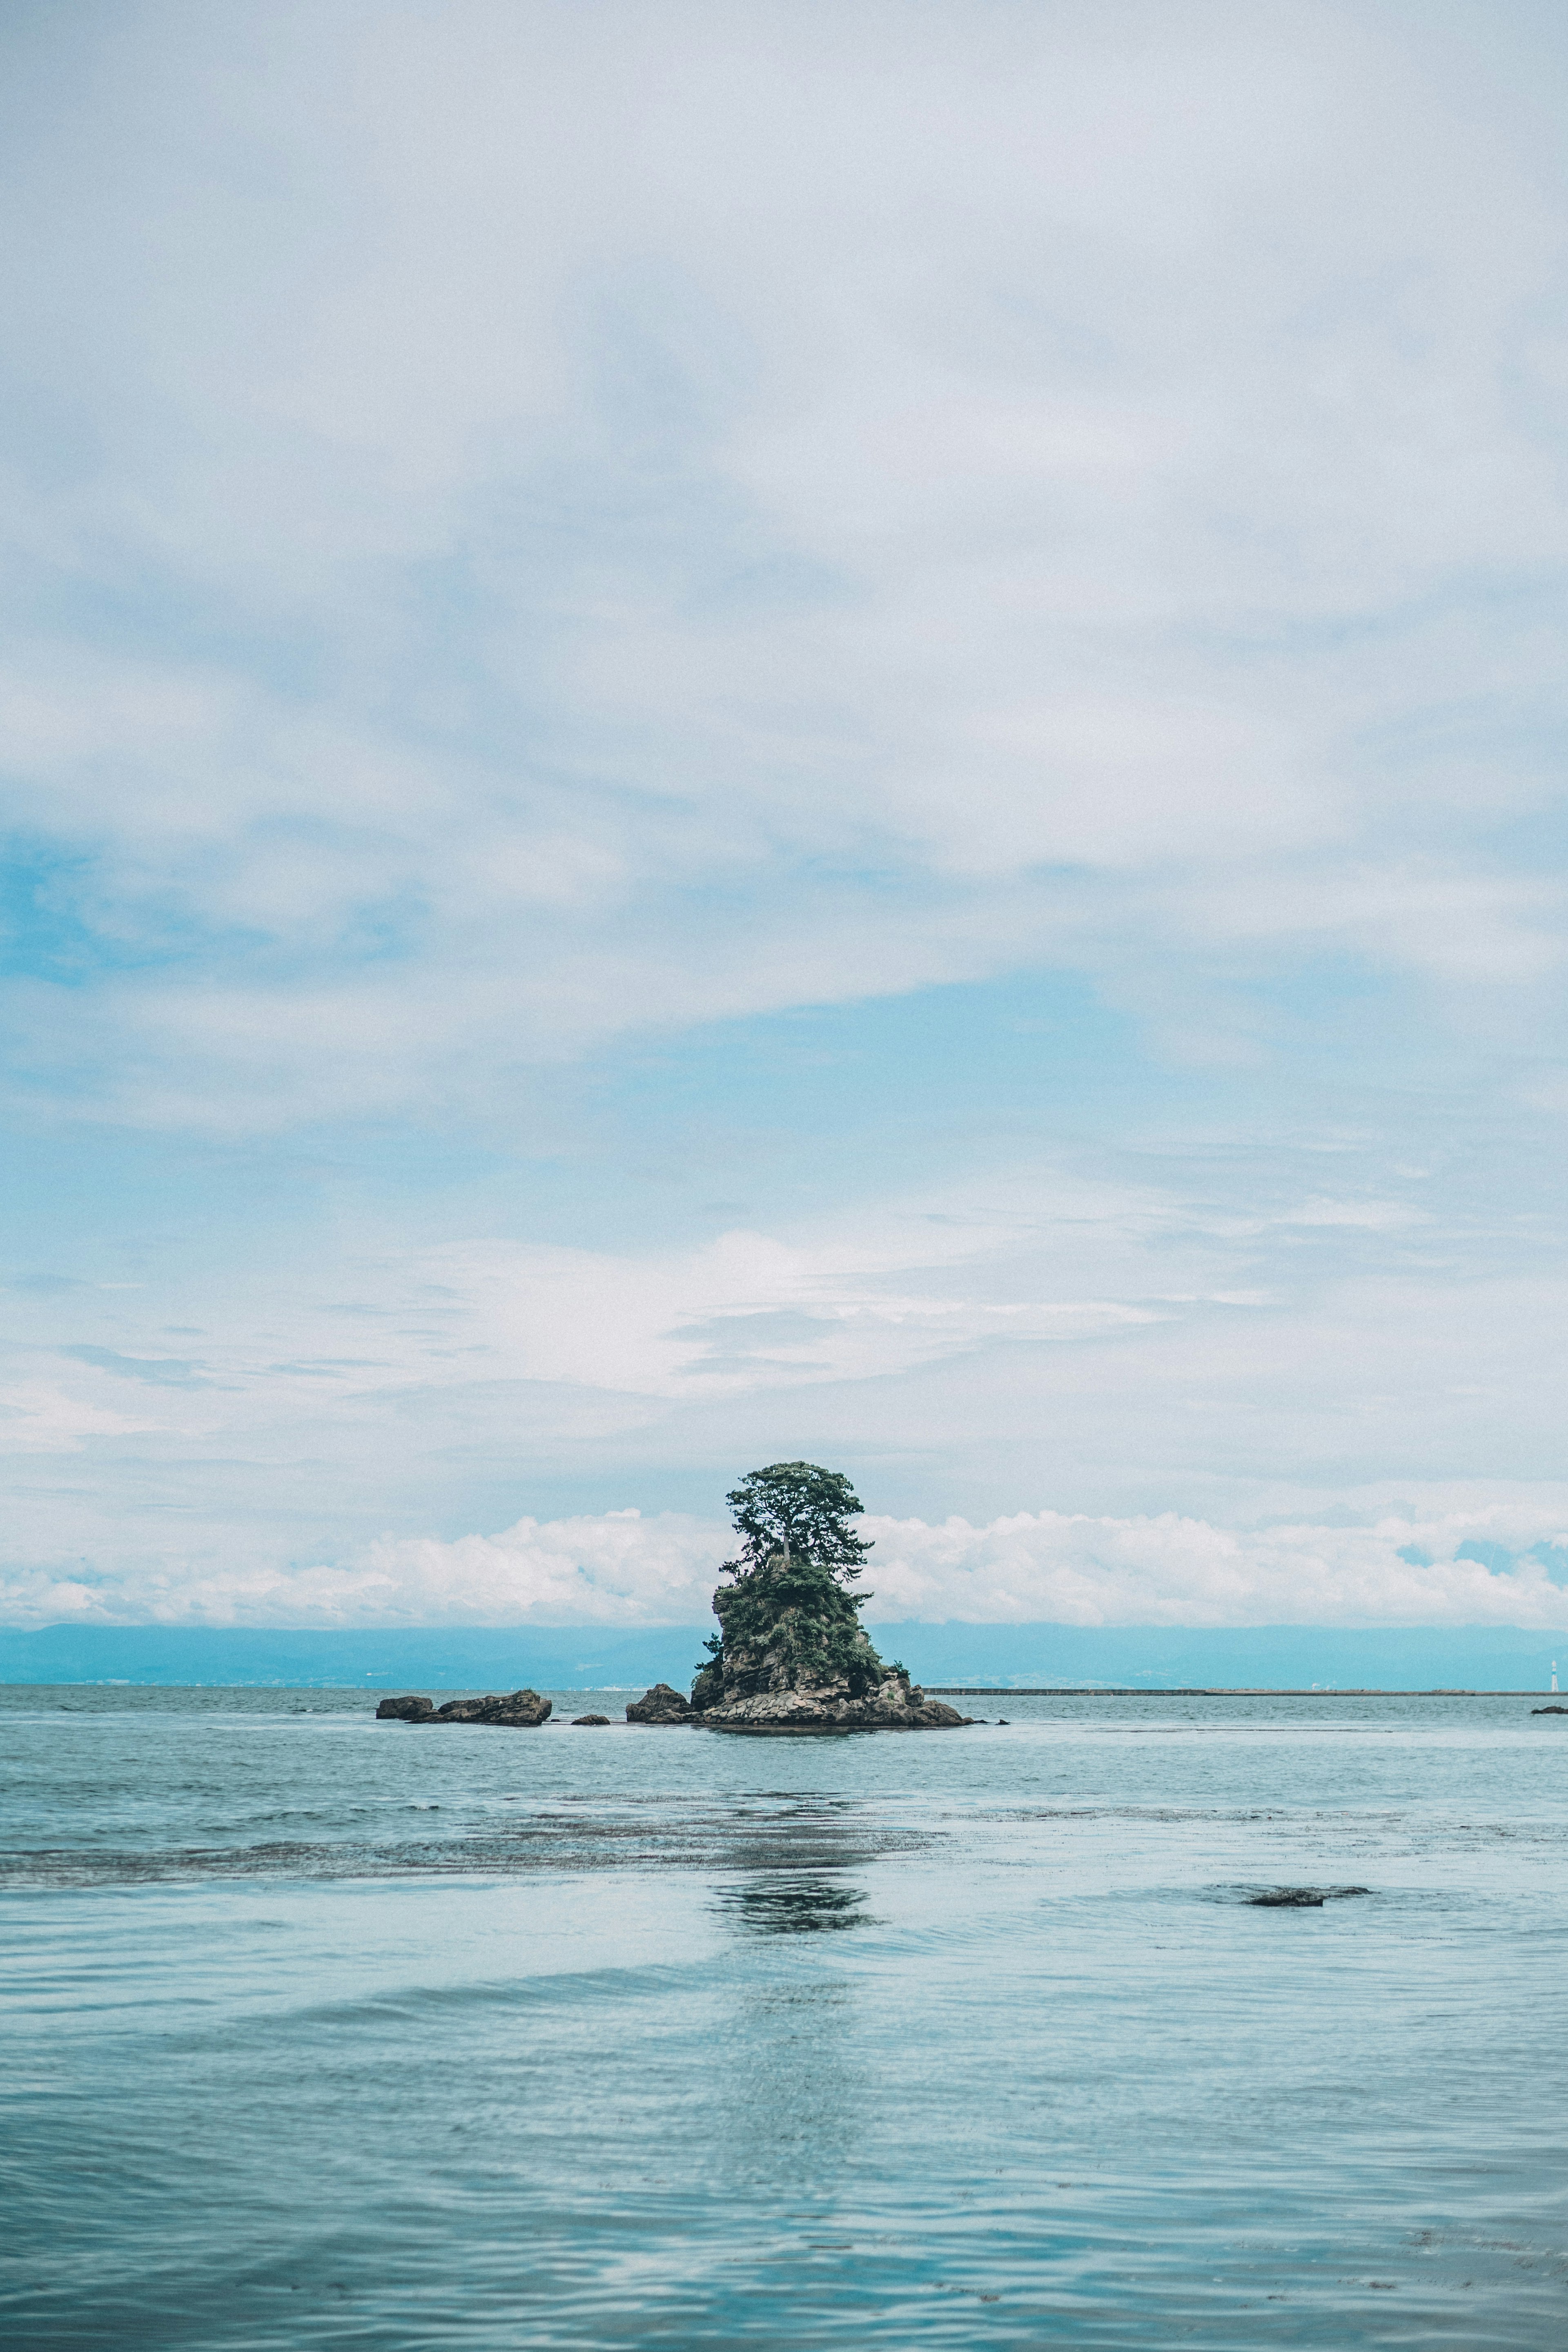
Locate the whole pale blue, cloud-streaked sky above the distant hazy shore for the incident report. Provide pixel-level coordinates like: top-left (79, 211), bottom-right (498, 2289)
top-left (0, 0), bottom-right (1568, 1630)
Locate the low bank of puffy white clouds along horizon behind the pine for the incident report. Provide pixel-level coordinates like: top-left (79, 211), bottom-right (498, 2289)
top-left (0, 1503), bottom-right (1568, 1630)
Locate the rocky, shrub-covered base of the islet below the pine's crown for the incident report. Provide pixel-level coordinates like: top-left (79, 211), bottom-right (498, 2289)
top-left (691, 1550), bottom-right (969, 1736)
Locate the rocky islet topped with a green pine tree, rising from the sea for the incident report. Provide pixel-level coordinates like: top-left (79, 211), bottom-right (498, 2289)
top-left (625, 1463), bottom-right (966, 1733)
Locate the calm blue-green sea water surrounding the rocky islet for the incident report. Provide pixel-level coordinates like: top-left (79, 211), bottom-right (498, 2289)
top-left (0, 1689), bottom-right (1568, 2352)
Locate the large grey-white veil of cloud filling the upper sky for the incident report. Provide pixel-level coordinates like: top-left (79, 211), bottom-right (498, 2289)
top-left (0, 7), bottom-right (1568, 1127)
